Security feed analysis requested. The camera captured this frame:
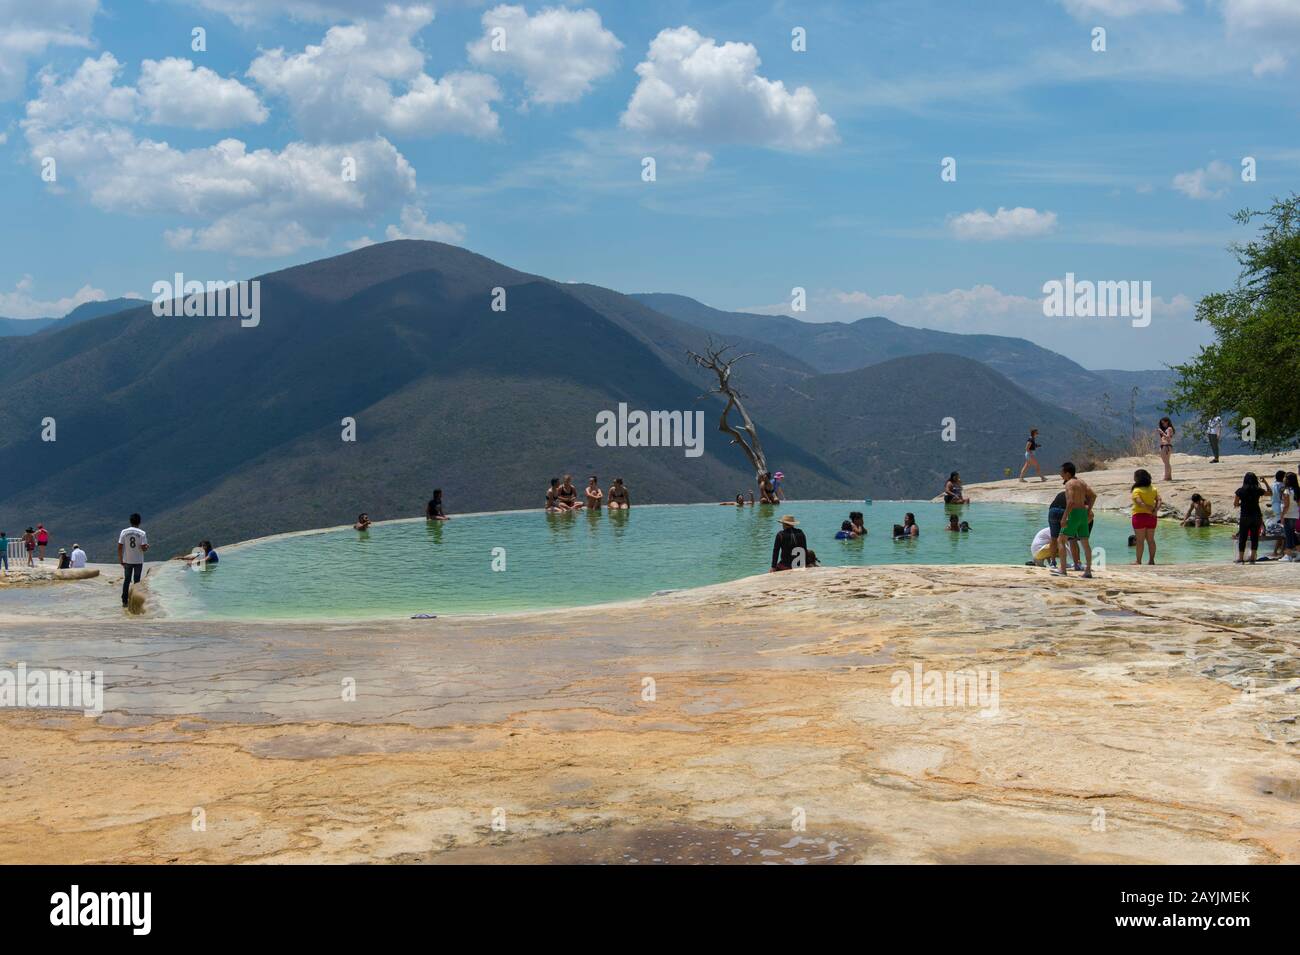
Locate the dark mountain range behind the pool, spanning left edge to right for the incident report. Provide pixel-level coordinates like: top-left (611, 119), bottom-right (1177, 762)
top-left (0, 240), bottom-right (1175, 560)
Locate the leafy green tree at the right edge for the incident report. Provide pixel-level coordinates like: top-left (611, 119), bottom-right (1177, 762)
top-left (1169, 194), bottom-right (1300, 451)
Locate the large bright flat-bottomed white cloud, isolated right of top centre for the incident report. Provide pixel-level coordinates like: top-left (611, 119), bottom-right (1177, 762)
top-left (620, 26), bottom-right (839, 149)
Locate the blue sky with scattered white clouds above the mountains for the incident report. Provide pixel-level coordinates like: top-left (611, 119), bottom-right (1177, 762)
top-left (0, 0), bottom-right (1300, 369)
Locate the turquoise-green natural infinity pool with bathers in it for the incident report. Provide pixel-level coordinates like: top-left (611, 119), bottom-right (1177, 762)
top-left (151, 500), bottom-right (1231, 618)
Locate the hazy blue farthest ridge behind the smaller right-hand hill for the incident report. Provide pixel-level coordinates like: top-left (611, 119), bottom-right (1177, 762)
top-left (632, 292), bottom-right (1171, 428)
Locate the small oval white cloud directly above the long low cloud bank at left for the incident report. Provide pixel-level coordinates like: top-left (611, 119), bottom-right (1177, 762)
top-left (138, 56), bottom-right (268, 130)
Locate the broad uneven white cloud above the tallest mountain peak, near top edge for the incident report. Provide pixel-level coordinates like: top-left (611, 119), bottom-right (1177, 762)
top-left (248, 6), bottom-right (501, 139)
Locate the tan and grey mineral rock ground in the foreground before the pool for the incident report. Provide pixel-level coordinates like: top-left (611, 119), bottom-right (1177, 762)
top-left (0, 561), bottom-right (1300, 864)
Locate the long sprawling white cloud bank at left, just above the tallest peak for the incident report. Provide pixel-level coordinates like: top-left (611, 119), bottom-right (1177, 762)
top-left (21, 55), bottom-right (416, 256)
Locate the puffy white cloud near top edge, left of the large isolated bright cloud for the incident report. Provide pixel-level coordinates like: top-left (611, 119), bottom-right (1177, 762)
top-left (467, 5), bottom-right (623, 105)
